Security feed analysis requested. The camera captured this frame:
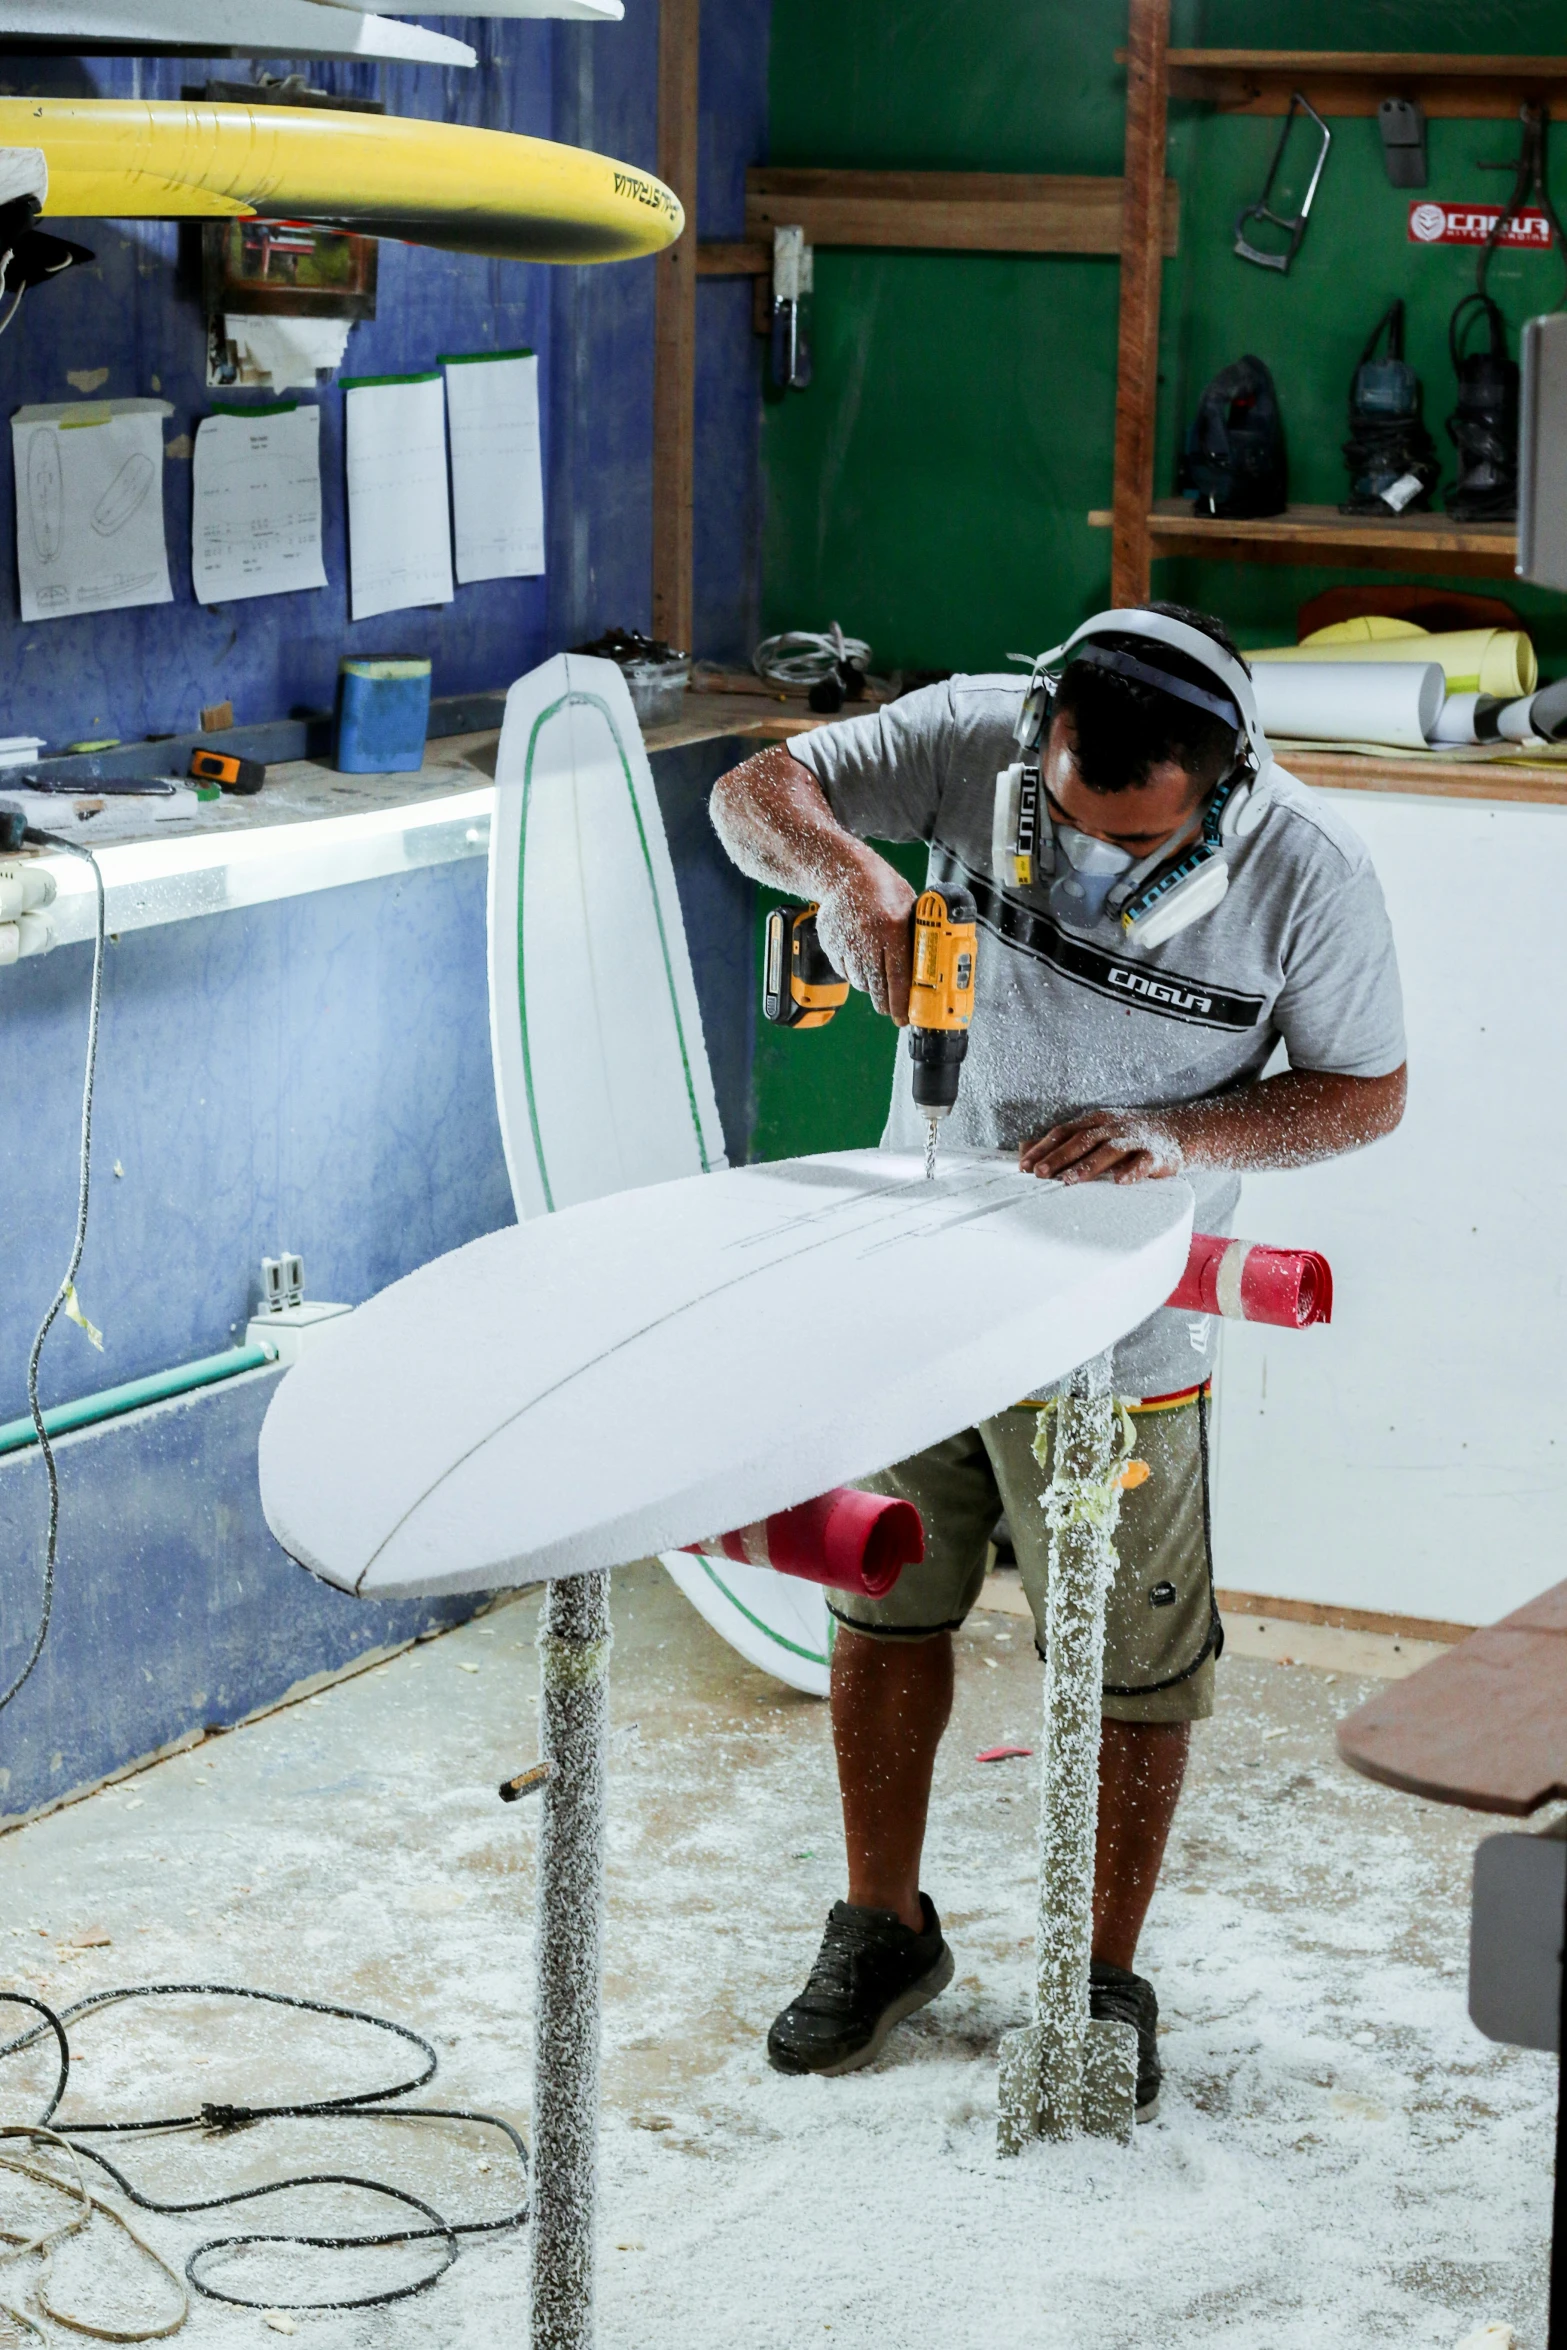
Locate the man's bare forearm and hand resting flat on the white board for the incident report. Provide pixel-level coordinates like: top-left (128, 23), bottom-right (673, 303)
top-left (1017, 1067), bottom-right (1407, 1182)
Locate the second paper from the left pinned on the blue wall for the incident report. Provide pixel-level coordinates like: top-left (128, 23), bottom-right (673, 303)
top-left (190, 404), bottom-right (327, 604)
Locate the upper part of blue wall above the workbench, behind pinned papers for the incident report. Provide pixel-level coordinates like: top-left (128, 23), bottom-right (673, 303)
top-left (0, 0), bottom-right (768, 745)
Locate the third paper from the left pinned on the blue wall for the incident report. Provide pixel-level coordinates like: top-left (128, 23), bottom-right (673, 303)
top-left (343, 374), bottom-right (453, 620)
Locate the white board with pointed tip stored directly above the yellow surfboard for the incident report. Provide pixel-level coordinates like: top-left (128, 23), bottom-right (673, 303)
top-left (0, 0), bottom-right (475, 66)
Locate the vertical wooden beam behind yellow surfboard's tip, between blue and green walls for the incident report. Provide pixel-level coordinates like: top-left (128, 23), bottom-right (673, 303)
top-left (653, 0), bottom-right (700, 651)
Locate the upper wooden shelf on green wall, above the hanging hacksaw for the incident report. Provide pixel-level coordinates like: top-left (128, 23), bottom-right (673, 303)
top-left (1151, 49), bottom-right (1567, 118)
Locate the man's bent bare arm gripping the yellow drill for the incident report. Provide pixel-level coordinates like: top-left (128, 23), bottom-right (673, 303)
top-left (709, 743), bottom-right (914, 1027)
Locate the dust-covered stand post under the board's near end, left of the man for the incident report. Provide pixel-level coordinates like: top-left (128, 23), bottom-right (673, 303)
top-left (529, 1575), bottom-right (611, 2350)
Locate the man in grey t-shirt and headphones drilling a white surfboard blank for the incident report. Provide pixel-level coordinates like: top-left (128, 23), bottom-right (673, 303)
top-left (712, 604), bottom-right (1405, 2120)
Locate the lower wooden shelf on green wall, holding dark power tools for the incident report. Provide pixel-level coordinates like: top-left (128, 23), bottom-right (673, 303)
top-left (1122, 498), bottom-right (1518, 578)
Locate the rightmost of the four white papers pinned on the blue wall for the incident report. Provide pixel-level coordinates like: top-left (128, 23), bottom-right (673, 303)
top-left (442, 350), bottom-right (545, 583)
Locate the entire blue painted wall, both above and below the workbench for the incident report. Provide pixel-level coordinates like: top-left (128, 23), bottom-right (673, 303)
top-left (0, 0), bottom-right (768, 1819)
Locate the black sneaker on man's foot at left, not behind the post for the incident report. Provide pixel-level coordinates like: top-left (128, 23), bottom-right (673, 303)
top-left (768, 1894), bottom-right (951, 2073)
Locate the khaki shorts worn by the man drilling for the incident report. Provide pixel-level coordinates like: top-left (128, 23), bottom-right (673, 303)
top-left (827, 1387), bottom-right (1224, 1723)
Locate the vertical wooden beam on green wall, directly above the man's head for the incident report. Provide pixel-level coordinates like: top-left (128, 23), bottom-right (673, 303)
top-left (1109, 0), bottom-right (1170, 604)
